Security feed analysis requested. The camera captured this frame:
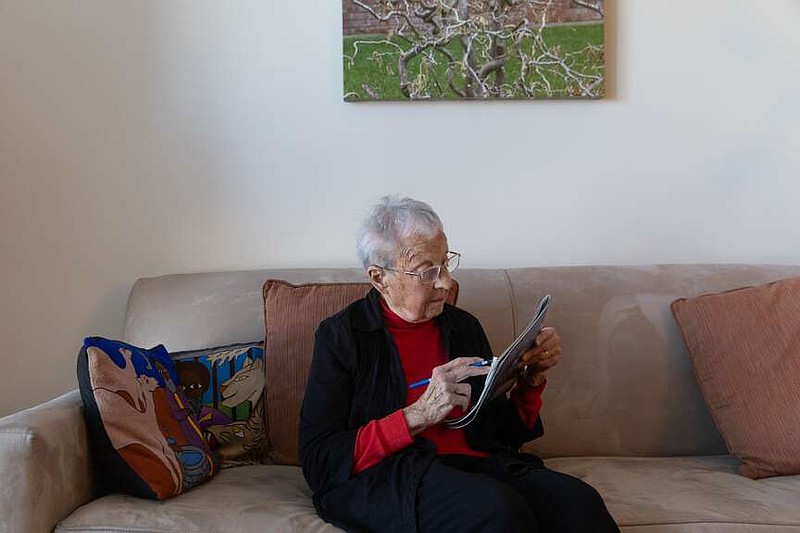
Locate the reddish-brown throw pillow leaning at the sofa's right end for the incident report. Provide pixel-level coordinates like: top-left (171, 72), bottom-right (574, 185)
top-left (672, 278), bottom-right (800, 479)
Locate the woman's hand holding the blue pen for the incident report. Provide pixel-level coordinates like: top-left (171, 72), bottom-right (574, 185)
top-left (403, 357), bottom-right (489, 435)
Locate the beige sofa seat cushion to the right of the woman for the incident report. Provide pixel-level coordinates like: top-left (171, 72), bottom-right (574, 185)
top-left (546, 455), bottom-right (800, 533)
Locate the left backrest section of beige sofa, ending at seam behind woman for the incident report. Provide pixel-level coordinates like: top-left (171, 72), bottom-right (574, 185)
top-left (123, 268), bottom-right (514, 352)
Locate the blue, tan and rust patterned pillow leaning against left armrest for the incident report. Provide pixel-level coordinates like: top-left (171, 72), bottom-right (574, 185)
top-left (78, 337), bottom-right (216, 500)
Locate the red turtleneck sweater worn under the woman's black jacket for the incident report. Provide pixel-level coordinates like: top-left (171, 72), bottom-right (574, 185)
top-left (353, 300), bottom-right (545, 474)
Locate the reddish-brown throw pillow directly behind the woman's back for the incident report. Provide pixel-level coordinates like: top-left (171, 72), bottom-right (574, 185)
top-left (263, 280), bottom-right (458, 465)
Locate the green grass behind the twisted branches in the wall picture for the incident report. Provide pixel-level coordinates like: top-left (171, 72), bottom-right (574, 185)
top-left (344, 24), bottom-right (604, 100)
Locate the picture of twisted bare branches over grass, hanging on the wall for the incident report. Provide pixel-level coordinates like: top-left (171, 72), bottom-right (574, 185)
top-left (342, 0), bottom-right (605, 101)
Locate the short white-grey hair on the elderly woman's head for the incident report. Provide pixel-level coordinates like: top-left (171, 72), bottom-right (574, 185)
top-left (356, 195), bottom-right (444, 268)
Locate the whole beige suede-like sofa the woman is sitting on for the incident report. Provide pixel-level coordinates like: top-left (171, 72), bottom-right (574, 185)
top-left (0, 265), bottom-right (800, 533)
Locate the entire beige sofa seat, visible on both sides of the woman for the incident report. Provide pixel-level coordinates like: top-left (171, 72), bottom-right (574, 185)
top-left (56, 456), bottom-right (800, 533)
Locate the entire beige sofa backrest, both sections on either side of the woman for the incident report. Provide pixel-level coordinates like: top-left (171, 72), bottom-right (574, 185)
top-left (123, 265), bottom-right (800, 457)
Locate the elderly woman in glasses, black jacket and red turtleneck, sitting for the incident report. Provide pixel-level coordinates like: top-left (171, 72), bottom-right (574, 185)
top-left (300, 197), bottom-right (619, 533)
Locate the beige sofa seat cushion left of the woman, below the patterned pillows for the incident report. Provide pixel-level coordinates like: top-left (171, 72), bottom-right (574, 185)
top-left (56, 465), bottom-right (340, 533)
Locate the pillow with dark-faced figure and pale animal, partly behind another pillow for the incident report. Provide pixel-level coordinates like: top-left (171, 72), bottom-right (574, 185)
top-left (172, 342), bottom-right (268, 468)
